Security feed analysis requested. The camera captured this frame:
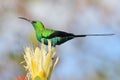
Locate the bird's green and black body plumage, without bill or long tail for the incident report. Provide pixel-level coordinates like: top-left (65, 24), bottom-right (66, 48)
top-left (32, 21), bottom-right (74, 46)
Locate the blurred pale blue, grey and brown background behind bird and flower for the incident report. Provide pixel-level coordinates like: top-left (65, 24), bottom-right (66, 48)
top-left (0, 0), bottom-right (120, 80)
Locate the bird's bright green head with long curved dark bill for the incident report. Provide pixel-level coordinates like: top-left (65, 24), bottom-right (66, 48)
top-left (19, 17), bottom-right (44, 31)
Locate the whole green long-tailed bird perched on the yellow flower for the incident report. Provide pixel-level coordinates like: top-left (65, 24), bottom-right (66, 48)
top-left (19, 17), bottom-right (114, 47)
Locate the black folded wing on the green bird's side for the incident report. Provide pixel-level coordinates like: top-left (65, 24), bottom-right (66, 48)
top-left (47, 31), bottom-right (74, 38)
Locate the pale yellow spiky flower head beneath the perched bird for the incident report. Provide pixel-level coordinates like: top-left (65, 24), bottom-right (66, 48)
top-left (24, 41), bottom-right (59, 80)
